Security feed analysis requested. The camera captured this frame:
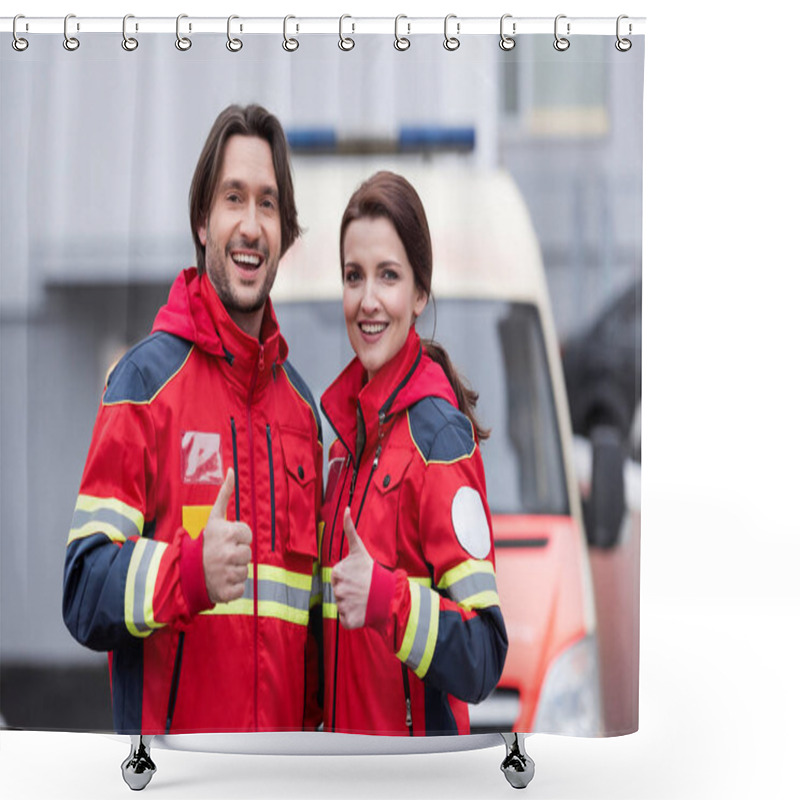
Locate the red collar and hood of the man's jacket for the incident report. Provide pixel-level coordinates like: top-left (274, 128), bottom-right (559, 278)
top-left (153, 267), bottom-right (289, 388)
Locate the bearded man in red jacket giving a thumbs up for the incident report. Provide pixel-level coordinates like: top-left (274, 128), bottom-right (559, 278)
top-left (63, 105), bottom-right (322, 734)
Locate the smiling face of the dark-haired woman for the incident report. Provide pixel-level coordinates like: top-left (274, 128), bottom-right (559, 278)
top-left (343, 217), bottom-right (428, 380)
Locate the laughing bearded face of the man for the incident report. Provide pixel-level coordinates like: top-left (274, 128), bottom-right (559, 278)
top-left (197, 134), bottom-right (281, 338)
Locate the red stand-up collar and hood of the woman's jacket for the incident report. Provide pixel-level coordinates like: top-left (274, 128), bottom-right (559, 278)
top-left (320, 327), bottom-right (457, 454)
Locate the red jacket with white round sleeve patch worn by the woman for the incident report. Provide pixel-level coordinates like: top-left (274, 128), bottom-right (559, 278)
top-left (321, 328), bottom-right (508, 735)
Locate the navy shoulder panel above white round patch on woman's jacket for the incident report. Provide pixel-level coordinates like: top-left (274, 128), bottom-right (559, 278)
top-left (408, 397), bottom-right (475, 461)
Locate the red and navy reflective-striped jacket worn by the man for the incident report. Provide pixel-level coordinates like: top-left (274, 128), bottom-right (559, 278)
top-left (63, 269), bottom-right (322, 733)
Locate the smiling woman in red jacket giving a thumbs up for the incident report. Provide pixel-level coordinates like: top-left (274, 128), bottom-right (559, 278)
top-left (321, 172), bottom-right (508, 735)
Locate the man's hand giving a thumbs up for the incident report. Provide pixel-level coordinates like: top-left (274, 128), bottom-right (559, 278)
top-left (203, 469), bottom-right (253, 604)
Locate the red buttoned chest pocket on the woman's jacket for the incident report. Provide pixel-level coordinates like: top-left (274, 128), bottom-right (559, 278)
top-left (361, 452), bottom-right (411, 568)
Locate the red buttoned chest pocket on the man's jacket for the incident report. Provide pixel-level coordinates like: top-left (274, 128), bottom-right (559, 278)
top-left (280, 429), bottom-right (317, 558)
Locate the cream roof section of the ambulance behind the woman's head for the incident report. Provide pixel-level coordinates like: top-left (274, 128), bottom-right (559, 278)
top-left (272, 159), bottom-right (549, 306)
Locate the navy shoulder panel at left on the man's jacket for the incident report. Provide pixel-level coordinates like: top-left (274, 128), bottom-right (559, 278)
top-left (103, 331), bottom-right (192, 405)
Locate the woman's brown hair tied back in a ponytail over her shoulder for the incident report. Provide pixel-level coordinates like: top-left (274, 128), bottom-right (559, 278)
top-left (339, 171), bottom-right (489, 442)
